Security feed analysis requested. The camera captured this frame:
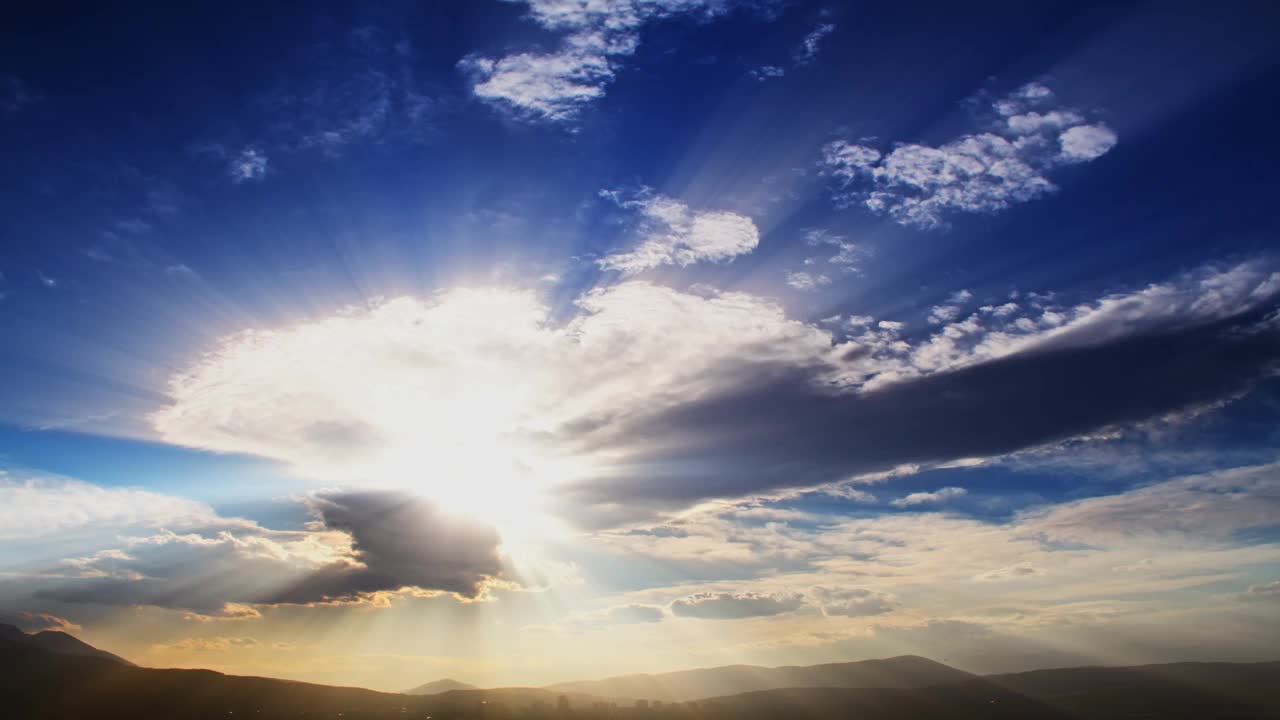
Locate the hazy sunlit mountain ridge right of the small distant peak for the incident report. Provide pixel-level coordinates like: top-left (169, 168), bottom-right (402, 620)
top-left (547, 655), bottom-right (974, 702)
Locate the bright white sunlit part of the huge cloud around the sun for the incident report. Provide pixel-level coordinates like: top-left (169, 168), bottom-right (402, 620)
top-left (154, 282), bottom-right (831, 511)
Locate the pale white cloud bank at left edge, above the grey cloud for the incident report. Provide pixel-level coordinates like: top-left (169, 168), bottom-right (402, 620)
top-left (0, 470), bottom-right (225, 541)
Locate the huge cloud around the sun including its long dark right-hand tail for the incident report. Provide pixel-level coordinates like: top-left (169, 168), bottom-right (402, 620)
top-left (154, 263), bottom-right (1280, 524)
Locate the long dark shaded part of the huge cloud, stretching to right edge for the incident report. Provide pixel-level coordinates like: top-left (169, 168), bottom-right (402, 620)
top-left (559, 306), bottom-right (1280, 525)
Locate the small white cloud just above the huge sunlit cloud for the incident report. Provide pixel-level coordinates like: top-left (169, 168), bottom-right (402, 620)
top-left (596, 190), bottom-right (760, 274)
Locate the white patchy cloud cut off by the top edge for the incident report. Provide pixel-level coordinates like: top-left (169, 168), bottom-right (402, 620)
top-left (458, 0), bottom-right (728, 123)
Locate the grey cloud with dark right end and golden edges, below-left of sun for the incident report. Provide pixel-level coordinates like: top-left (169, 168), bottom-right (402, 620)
top-left (27, 481), bottom-right (506, 609)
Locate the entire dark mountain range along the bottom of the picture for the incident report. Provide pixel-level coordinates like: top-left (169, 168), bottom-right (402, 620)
top-left (0, 625), bottom-right (1280, 720)
